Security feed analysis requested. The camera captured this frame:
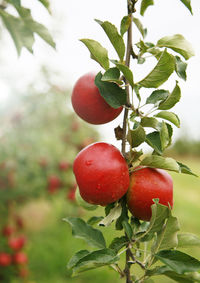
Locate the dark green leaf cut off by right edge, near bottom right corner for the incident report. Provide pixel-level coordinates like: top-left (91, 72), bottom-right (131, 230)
top-left (155, 250), bottom-right (200, 274)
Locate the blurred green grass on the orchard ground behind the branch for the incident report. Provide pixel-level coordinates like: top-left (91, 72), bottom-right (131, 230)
top-left (13, 160), bottom-right (200, 283)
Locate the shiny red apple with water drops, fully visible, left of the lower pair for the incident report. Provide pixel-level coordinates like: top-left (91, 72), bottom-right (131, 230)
top-left (73, 142), bottom-right (129, 206)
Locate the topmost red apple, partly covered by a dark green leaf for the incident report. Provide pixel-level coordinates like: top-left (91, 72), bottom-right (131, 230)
top-left (71, 73), bottom-right (123, 125)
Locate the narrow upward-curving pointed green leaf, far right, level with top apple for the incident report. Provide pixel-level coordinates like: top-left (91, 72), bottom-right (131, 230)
top-left (158, 82), bottom-right (181, 110)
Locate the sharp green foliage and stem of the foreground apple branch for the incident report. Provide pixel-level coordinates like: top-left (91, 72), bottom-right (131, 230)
top-left (65, 0), bottom-right (200, 283)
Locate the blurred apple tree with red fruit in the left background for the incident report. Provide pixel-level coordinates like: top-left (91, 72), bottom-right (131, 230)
top-left (0, 71), bottom-right (98, 282)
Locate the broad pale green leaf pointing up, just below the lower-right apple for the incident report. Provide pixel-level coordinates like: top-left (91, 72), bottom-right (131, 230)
top-left (154, 215), bottom-right (180, 251)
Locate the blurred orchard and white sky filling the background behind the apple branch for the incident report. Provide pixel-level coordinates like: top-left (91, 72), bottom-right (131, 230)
top-left (0, 0), bottom-right (200, 283)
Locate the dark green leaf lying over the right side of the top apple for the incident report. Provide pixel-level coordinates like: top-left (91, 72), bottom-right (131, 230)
top-left (95, 72), bottom-right (126, 108)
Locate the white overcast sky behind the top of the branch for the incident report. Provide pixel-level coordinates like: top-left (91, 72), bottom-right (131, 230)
top-left (0, 0), bottom-right (200, 146)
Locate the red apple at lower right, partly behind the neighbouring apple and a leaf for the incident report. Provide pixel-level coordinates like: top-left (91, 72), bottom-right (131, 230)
top-left (127, 168), bottom-right (173, 221)
